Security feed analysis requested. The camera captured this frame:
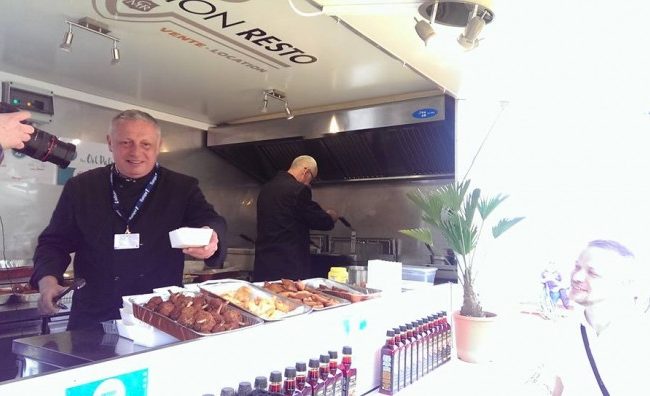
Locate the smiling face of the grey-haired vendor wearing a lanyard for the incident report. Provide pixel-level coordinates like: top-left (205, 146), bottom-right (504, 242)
top-left (107, 120), bottom-right (161, 179)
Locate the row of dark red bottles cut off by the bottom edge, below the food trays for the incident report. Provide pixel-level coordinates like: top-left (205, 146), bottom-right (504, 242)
top-left (211, 346), bottom-right (357, 396)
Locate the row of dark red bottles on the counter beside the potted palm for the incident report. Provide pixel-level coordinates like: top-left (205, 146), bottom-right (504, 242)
top-left (379, 311), bottom-right (451, 395)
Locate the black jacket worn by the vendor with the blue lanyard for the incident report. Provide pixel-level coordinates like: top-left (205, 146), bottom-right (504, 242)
top-left (30, 165), bottom-right (227, 330)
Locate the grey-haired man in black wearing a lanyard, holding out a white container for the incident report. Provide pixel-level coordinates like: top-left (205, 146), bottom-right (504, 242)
top-left (31, 110), bottom-right (226, 330)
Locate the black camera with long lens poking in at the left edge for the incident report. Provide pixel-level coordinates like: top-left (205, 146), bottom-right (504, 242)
top-left (0, 102), bottom-right (77, 169)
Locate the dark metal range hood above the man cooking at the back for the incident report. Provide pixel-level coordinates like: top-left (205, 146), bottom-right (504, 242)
top-left (207, 95), bottom-right (455, 184)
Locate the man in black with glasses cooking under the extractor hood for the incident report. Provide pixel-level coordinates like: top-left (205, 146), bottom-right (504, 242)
top-left (253, 155), bottom-right (338, 281)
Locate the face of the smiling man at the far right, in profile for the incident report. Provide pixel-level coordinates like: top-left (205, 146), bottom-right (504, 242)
top-left (569, 247), bottom-right (625, 306)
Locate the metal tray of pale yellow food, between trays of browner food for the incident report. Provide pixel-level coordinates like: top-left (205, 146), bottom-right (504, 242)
top-left (199, 279), bottom-right (312, 322)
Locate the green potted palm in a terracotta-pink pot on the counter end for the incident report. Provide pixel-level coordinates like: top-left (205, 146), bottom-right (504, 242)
top-left (400, 180), bottom-right (523, 361)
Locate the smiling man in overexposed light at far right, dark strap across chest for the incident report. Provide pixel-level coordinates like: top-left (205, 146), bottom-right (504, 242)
top-left (553, 240), bottom-right (650, 395)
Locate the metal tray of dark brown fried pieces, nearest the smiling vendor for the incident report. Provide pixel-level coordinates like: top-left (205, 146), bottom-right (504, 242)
top-left (130, 291), bottom-right (264, 341)
